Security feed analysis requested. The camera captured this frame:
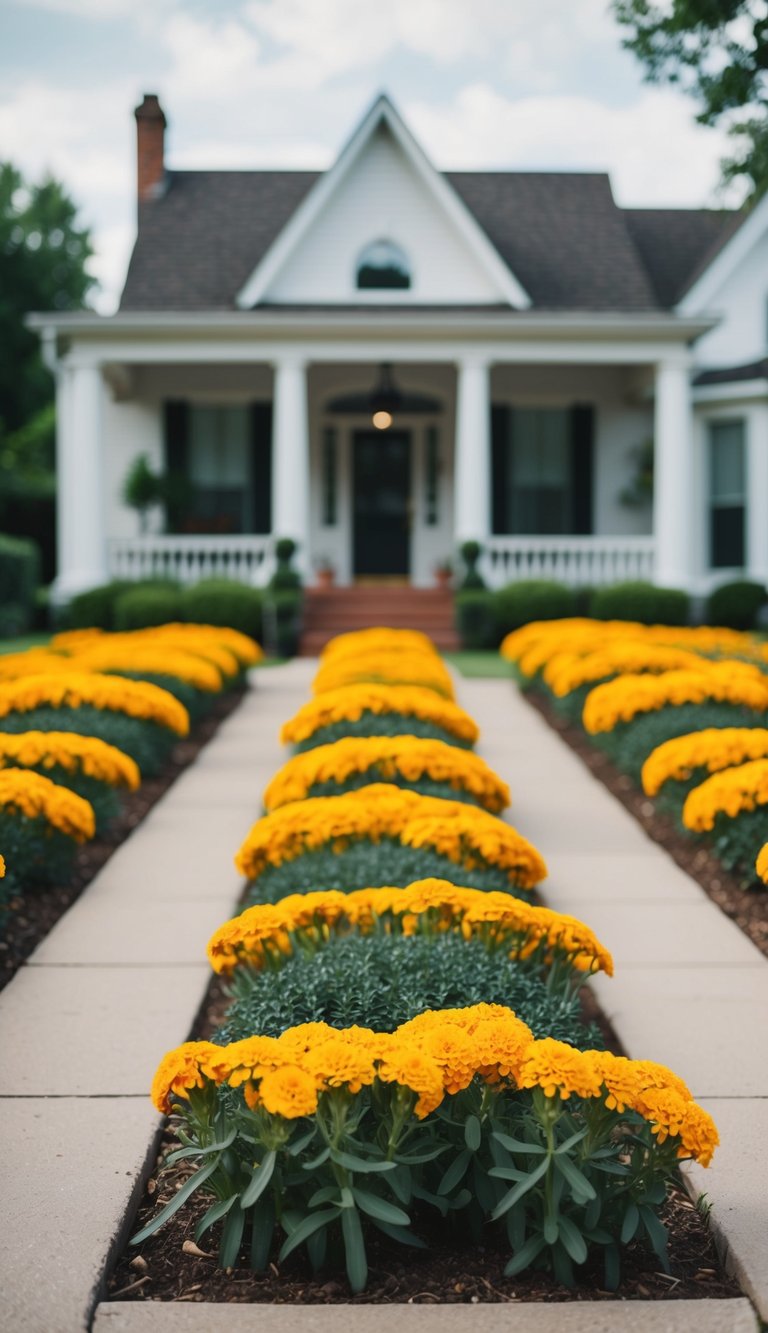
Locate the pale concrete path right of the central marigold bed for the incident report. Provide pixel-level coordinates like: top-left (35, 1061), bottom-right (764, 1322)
top-left (461, 680), bottom-right (768, 1320)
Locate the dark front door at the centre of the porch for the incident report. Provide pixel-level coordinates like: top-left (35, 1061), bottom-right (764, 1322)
top-left (352, 431), bottom-right (411, 576)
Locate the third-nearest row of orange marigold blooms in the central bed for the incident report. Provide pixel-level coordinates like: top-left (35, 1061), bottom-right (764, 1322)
top-left (236, 782), bottom-right (547, 888)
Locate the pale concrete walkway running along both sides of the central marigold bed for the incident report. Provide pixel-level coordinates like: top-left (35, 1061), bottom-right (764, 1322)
top-left (0, 660), bottom-right (768, 1333)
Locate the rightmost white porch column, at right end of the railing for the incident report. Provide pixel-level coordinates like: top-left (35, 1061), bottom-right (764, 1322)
top-left (653, 357), bottom-right (696, 589)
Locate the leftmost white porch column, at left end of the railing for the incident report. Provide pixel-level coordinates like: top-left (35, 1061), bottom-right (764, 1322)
top-left (53, 363), bottom-right (108, 604)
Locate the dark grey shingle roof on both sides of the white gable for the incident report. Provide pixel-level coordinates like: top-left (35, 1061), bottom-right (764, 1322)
top-left (120, 171), bottom-right (740, 312)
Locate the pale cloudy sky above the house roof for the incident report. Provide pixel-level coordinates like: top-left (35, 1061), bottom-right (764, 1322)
top-left (0, 0), bottom-right (733, 312)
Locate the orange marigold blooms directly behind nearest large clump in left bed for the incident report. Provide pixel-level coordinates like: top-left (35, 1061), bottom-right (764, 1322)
top-left (0, 732), bottom-right (141, 792)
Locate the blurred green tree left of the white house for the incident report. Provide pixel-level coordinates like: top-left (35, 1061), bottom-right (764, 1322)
top-left (0, 163), bottom-right (95, 437)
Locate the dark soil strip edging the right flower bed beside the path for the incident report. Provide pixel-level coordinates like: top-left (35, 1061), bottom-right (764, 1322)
top-left (524, 690), bottom-right (768, 957)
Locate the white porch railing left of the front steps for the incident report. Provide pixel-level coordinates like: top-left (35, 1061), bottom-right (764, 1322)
top-left (109, 535), bottom-right (272, 585)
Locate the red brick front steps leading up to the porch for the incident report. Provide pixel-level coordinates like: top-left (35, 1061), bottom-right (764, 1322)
top-left (299, 584), bottom-right (459, 657)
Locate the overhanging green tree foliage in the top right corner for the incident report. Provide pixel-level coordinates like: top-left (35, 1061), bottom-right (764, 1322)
top-left (612, 0), bottom-right (768, 197)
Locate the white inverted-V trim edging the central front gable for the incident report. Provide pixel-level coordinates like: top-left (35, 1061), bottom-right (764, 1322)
top-left (237, 93), bottom-right (531, 309)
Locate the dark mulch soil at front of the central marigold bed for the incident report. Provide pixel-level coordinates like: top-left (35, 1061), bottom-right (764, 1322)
top-left (107, 1132), bottom-right (741, 1305)
